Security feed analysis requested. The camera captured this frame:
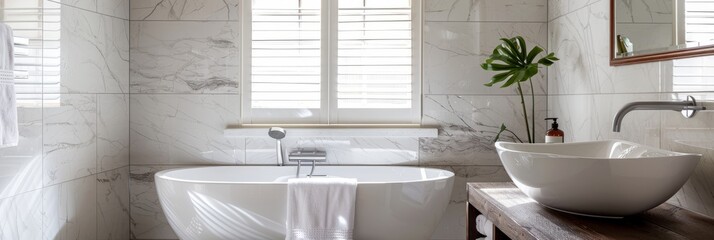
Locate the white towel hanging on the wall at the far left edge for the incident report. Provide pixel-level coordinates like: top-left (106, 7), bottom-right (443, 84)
top-left (0, 23), bottom-right (19, 147)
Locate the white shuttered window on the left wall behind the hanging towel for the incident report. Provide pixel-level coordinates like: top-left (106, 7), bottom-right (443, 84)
top-left (0, 0), bottom-right (60, 107)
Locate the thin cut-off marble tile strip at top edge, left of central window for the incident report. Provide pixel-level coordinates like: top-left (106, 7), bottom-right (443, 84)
top-left (131, 0), bottom-right (241, 21)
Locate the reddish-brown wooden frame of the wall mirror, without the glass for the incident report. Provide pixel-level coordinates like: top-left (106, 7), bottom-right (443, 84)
top-left (610, 0), bottom-right (714, 66)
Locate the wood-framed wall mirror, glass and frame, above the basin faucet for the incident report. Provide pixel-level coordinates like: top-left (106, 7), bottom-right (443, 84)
top-left (610, 0), bottom-right (714, 66)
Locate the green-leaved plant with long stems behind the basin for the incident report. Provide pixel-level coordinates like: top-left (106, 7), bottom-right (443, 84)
top-left (481, 36), bottom-right (559, 143)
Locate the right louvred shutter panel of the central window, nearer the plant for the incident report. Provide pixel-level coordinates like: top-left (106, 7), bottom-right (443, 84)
top-left (337, 0), bottom-right (413, 108)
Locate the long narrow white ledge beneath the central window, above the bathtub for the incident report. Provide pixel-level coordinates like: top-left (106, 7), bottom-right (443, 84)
top-left (223, 127), bottom-right (438, 138)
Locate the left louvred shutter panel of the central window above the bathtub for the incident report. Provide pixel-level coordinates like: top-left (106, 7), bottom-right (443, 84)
top-left (251, 0), bottom-right (321, 108)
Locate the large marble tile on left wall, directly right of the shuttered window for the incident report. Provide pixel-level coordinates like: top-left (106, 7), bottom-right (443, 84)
top-left (59, 6), bottom-right (129, 93)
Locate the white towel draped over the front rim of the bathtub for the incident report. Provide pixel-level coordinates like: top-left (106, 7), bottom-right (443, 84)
top-left (285, 178), bottom-right (357, 240)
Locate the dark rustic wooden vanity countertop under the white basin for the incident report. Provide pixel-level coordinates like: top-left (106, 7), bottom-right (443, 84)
top-left (468, 182), bottom-right (714, 239)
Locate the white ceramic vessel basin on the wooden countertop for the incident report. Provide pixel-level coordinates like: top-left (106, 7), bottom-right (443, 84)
top-left (496, 140), bottom-right (701, 217)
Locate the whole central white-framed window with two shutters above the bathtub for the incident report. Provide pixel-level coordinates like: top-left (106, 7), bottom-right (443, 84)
top-left (242, 0), bottom-right (421, 124)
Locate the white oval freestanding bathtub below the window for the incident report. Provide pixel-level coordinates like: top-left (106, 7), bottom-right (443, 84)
top-left (155, 166), bottom-right (454, 240)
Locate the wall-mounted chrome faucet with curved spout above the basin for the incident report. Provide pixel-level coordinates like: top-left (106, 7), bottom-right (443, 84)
top-left (612, 96), bottom-right (706, 132)
